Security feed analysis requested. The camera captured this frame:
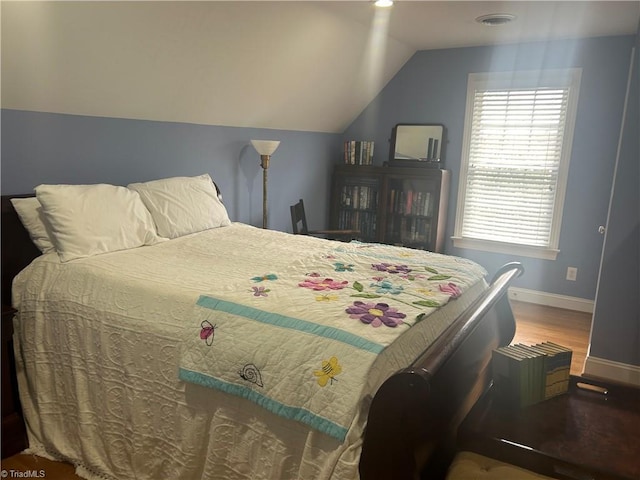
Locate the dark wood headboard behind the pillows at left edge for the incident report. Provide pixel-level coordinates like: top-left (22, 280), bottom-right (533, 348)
top-left (1, 194), bottom-right (41, 305)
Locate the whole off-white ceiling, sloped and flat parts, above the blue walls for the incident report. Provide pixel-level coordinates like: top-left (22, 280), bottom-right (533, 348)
top-left (1, 1), bottom-right (640, 133)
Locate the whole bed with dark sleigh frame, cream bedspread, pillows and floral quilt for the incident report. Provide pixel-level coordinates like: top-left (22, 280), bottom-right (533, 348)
top-left (2, 176), bottom-right (522, 480)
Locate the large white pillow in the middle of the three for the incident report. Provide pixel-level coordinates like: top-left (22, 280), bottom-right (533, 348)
top-left (36, 184), bottom-right (160, 262)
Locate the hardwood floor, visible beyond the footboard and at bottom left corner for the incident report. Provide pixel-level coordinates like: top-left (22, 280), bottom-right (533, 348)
top-left (2, 302), bottom-right (591, 480)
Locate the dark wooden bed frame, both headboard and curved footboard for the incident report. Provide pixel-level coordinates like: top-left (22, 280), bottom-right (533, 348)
top-left (2, 195), bottom-right (523, 480)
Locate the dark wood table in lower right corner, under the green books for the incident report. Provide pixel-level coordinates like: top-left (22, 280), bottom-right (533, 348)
top-left (458, 377), bottom-right (640, 480)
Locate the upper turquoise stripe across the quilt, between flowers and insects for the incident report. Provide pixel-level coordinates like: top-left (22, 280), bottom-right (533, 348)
top-left (197, 295), bottom-right (384, 353)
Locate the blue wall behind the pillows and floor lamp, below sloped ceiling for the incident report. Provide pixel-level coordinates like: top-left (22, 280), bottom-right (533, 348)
top-left (1, 109), bottom-right (342, 232)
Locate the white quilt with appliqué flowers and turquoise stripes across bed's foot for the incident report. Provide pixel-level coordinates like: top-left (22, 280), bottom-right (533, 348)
top-left (179, 242), bottom-right (486, 440)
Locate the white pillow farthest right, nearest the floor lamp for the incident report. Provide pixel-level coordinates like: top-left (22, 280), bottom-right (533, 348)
top-left (128, 174), bottom-right (231, 238)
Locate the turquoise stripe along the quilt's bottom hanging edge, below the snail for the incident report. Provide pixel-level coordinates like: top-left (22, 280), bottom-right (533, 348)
top-left (178, 367), bottom-right (347, 441)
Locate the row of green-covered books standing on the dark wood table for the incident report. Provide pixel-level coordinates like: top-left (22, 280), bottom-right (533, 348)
top-left (491, 342), bottom-right (573, 407)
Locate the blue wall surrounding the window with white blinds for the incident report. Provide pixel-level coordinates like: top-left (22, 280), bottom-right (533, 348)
top-left (344, 36), bottom-right (634, 300)
